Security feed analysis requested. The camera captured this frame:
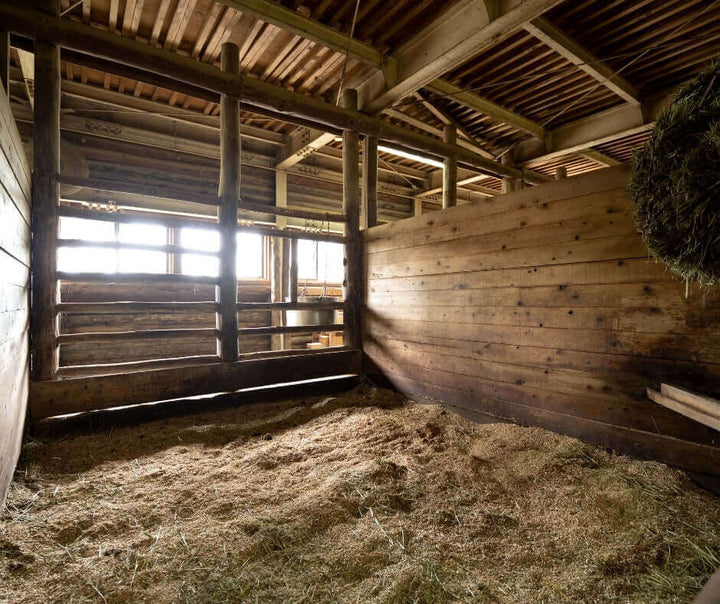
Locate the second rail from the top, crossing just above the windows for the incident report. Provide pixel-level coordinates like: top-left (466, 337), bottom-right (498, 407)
top-left (59, 206), bottom-right (345, 243)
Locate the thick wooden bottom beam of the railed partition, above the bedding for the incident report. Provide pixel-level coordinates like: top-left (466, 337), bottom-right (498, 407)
top-left (30, 350), bottom-right (361, 421)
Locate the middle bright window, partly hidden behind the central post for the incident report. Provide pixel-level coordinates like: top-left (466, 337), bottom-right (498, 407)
top-left (180, 228), bottom-right (265, 279)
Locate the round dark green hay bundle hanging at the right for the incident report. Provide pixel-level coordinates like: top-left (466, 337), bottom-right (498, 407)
top-left (628, 61), bottom-right (720, 285)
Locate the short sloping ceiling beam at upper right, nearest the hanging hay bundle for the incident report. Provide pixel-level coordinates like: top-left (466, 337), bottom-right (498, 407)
top-left (524, 17), bottom-right (641, 104)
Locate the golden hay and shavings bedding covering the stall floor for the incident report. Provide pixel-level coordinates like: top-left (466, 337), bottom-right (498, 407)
top-left (0, 386), bottom-right (720, 604)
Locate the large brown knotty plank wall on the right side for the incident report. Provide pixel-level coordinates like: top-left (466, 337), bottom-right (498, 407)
top-left (364, 167), bottom-right (720, 474)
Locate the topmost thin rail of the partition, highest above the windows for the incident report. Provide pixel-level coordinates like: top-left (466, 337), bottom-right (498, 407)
top-left (58, 174), bottom-right (347, 222)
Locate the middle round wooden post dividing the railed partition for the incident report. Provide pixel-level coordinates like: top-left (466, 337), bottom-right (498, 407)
top-left (215, 42), bottom-right (240, 361)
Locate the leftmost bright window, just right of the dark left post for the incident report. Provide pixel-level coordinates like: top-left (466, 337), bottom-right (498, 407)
top-left (58, 217), bottom-right (167, 273)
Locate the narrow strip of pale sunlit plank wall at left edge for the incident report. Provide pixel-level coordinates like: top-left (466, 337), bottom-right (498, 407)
top-left (0, 81), bottom-right (30, 505)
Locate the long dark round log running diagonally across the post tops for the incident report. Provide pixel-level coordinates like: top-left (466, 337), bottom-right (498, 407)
top-left (0, 0), bottom-right (520, 178)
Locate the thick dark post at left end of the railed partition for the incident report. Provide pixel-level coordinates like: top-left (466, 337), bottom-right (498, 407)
top-left (30, 0), bottom-right (60, 380)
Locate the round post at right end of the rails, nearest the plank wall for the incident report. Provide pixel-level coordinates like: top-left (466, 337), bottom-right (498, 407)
top-left (342, 89), bottom-right (362, 348)
